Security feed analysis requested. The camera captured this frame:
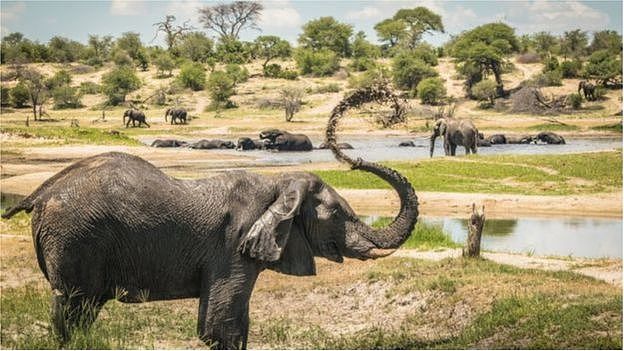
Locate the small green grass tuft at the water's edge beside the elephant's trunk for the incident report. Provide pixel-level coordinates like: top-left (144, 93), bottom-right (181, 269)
top-left (372, 217), bottom-right (461, 250)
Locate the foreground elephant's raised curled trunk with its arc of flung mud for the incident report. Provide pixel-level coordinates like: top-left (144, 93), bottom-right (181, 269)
top-left (325, 85), bottom-right (418, 258)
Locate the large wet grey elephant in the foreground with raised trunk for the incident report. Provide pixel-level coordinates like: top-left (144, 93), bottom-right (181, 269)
top-left (2, 152), bottom-right (418, 348)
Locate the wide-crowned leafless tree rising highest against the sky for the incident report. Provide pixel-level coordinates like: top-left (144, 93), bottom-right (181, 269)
top-left (198, 1), bottom-right (264, 40)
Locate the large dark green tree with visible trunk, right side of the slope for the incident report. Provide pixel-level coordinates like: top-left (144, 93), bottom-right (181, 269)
top-left (451, 23), bottom-right (518, 96)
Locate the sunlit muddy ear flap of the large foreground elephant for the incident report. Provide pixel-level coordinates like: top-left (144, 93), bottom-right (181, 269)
top-left (239, 179), bottom-right (309, 263)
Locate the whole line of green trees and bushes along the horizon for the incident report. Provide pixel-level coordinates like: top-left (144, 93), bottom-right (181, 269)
top-left (1, 1), bottom-right (622, 119)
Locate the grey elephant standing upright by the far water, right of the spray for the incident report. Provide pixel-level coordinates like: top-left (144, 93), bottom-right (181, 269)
top-left (429, 118), bottom-right (479, 157)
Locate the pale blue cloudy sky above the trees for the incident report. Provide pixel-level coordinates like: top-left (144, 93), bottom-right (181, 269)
top-left (0, 0), bottom-right (622, 45)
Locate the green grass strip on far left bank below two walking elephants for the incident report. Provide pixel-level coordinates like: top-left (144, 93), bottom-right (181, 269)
top-left (0, 126), bottom-right (141, 146)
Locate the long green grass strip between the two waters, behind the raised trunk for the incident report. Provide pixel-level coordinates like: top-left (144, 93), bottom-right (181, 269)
top-left (313, 151), bottom-right (622, 195)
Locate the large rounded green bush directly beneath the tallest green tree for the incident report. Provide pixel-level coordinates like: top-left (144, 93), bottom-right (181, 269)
top-left (392, 52), bottom-right (438, 90)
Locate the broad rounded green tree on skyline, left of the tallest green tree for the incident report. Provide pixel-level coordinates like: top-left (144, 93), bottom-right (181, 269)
top-left (298, 17), bottom-right (353, 57)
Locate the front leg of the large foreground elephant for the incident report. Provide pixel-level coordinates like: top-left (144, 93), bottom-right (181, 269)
top-left (197, 273), bottom-right (257, 349)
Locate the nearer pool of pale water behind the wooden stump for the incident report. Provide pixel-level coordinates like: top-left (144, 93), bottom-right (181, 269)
top-left (364, 216), bottom-right (622, 259)
